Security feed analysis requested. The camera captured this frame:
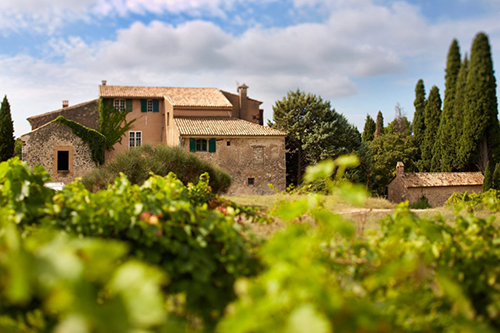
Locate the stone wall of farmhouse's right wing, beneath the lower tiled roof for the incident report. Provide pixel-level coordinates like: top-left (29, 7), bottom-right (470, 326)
top-left (181, 137), bottom-right (286, 195)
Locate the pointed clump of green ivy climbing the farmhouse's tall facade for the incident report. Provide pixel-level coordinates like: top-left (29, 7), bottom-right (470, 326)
top-left (98, 98), bottom-right (136, 150)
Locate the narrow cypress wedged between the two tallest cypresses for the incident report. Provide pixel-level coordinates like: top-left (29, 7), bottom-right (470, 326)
top-left (450, 54), bottom-right (469, 171)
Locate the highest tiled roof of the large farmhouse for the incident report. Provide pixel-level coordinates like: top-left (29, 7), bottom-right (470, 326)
top-left (99, 85), bottom-right (233, 108)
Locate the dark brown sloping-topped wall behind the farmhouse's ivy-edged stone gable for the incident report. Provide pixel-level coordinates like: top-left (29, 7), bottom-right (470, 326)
top-left (28, 99), bottom-right (99, 130)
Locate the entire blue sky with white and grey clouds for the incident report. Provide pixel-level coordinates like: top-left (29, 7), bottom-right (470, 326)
top-left (0, 0), bottom-right (500, 136)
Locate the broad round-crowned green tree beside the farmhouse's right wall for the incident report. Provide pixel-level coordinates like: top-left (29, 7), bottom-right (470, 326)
top-left (269, 89), bottom-right (361, 184)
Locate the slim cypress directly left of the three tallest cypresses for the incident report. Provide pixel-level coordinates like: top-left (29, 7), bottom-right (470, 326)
top-left (421, 86), bottom-right (441, 171)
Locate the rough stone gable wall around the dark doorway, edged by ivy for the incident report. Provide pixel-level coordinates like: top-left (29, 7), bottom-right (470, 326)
top-left (21, 123), bottom-right (95, 183)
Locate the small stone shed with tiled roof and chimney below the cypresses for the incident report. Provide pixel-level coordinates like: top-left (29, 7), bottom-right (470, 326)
top-left (387, 162), bottom-right (484, 207)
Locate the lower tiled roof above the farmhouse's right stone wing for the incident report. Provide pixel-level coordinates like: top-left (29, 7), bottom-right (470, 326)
top-left (174, 117), bottom-right (286, 136)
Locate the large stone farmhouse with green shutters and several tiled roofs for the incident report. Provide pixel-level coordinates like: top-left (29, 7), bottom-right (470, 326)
top-left (21, 81), bottom-right (286, 194)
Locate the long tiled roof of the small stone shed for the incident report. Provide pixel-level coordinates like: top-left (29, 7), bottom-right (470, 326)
top-left (401, 172), bottom-right (484, 187)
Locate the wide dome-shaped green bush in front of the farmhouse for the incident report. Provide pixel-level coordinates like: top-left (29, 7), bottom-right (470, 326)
top-left (83, 145), bottom-right (231, 193)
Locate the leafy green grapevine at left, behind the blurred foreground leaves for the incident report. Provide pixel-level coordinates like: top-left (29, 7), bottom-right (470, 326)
top-left (0, 159), bottom-right (256, 325)
